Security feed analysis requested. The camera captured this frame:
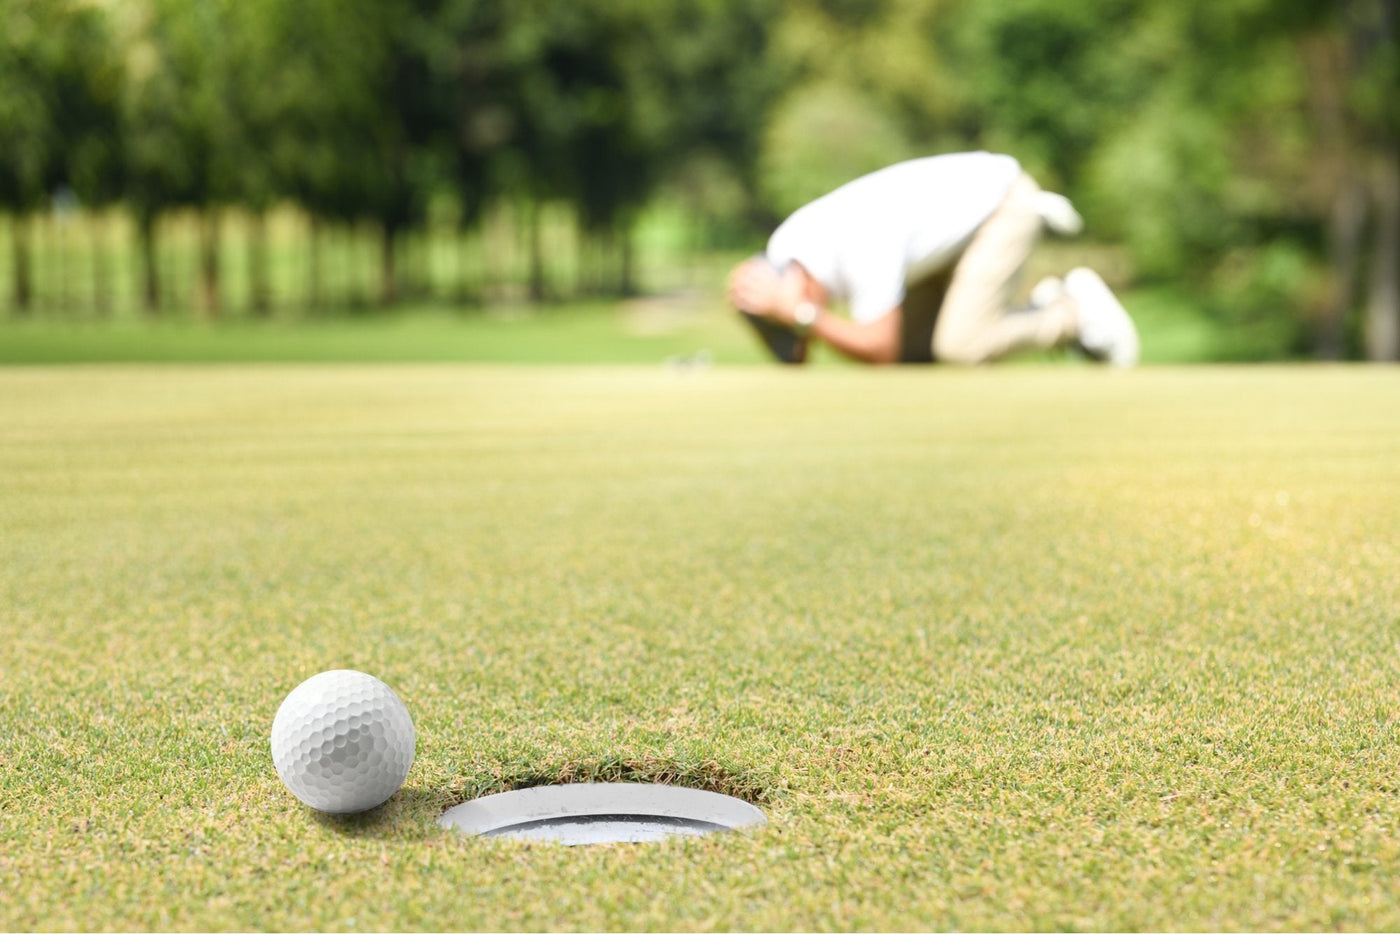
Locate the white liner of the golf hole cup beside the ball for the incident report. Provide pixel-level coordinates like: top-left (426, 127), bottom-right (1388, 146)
top-left (438, 781), bottom-right (767, 846)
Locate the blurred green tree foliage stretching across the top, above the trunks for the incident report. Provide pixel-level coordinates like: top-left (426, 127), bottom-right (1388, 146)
top-left (0, 0), bottom-right (1400, 350)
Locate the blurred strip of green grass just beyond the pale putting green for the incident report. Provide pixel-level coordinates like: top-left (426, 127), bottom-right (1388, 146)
top-left (0, 281), bottom-right (1287, 364)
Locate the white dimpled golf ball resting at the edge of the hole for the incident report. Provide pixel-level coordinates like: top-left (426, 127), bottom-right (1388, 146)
top-left (272, 669), bottom-right (416, 814)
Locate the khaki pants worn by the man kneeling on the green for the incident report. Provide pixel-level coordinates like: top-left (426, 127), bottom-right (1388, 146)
top-left (900, 174), bottom-right (1078, 364)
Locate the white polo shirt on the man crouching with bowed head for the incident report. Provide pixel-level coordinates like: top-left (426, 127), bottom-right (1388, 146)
top-left (767, 153), bottom-right (1021, 322)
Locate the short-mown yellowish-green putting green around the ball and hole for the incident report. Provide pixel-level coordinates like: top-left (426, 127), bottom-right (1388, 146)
top-left (0, 365), bottom-right (1400, 930)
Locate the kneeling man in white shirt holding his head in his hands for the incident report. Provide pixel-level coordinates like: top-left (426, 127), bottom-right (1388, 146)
top-left (728, 153), bottom-right (1138, 367)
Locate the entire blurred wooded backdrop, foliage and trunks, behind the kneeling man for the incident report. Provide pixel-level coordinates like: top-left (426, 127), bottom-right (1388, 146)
top-left (0, 0), bottom-right (1400, 360)
